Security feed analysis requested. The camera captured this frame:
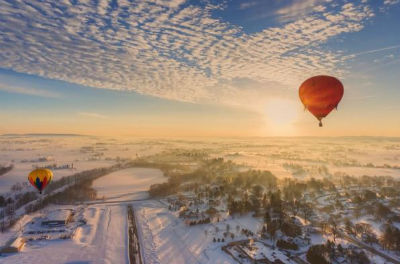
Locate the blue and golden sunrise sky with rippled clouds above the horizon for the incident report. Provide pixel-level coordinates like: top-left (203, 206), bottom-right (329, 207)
top-left (0, 0), bottom-right (400, 137)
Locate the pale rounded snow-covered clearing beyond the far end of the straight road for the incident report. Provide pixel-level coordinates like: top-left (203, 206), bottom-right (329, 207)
top-left (92, 168), bottom-right (167, 201)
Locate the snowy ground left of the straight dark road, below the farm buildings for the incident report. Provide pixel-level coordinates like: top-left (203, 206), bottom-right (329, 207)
top-left (0, 205), bottom-right (128, 264)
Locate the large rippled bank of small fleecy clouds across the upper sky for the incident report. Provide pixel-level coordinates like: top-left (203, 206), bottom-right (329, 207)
top-left (0, 0), bottom-right (373, 109)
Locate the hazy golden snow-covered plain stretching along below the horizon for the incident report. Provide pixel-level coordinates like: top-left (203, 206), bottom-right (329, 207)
top-left (0, 135), bottom-right (400, 193)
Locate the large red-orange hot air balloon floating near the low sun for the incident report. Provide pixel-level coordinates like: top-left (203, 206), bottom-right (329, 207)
top-left (299, 75), bottom-right (344, 127)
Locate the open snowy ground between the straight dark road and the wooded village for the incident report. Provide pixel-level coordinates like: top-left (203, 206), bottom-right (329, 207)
top-left (134, 200), bottom-right (262, 264)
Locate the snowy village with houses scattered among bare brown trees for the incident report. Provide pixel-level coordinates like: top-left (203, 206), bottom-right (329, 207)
top-left (155, 166), bottom-right (400, 264)
